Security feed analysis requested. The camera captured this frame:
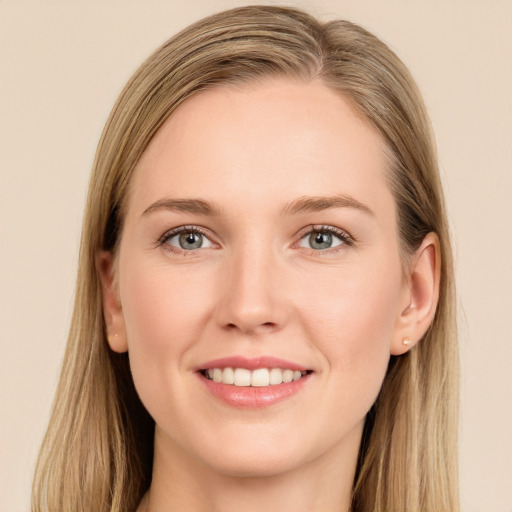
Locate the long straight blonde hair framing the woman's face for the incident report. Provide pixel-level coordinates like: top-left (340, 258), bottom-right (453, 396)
top-left (32, 6), bottom-right (459, 512)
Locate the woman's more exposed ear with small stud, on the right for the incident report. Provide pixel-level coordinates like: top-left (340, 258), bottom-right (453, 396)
top-left (391, 233), bottom-right (441, 355)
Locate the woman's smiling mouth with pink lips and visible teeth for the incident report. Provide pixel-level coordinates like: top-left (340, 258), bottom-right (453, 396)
top-left (197, 357), bottom-right (314, 408)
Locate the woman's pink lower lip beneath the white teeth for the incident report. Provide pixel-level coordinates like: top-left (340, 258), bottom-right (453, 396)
top-left (198, 373), bottom-right (311, 409)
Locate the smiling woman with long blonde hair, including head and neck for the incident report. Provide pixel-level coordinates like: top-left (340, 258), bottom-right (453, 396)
top-left (33, 7), bottom-right (458, 512)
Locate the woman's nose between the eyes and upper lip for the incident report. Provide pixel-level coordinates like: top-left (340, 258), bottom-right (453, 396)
top-left (217, 241), bottom-right (289, 335)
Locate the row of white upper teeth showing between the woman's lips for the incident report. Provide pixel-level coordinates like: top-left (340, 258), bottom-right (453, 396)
top-left (203, 367), bottom-right (307, 387)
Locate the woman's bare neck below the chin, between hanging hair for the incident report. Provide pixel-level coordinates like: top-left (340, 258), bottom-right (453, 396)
top-left (142, 424), bottom-right (361, 512)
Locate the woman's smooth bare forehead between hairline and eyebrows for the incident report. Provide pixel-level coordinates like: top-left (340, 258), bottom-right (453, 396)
top-left (128, 80), bottom-right (390, 219)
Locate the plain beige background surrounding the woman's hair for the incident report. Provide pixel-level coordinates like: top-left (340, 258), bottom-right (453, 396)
top-left (0, 0), bottom-right (512, 512)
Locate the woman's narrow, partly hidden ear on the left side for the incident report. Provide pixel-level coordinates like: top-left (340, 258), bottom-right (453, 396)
top-left (96, 251), bottom-right (128, 353)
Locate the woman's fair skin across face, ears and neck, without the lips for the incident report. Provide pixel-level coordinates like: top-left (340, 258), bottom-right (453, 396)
top-left (99, 80), bottom-right (439, 512)
